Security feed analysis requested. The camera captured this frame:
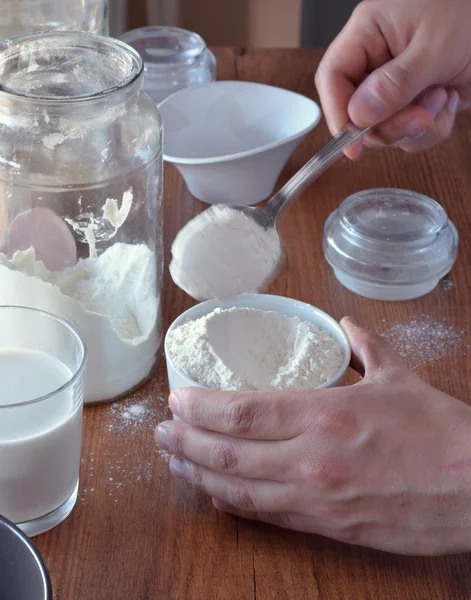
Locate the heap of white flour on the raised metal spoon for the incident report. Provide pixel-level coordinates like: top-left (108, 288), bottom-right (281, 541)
top-left (170, 204), bottom-right (282, 300)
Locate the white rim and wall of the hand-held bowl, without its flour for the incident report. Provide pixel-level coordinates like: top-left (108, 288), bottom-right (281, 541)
top-left (165, 294), bottom-right (351, 404)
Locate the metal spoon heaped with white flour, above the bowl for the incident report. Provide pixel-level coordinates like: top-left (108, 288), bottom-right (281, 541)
top-left (170, 124), bottom-right (369, 300)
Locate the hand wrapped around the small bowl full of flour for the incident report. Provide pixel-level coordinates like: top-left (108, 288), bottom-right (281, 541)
top-left (156, 319), bottom-right (471, 555)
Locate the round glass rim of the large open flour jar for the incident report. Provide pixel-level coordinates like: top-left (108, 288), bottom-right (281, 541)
top-left (0, 31), bottom-right (144, 104)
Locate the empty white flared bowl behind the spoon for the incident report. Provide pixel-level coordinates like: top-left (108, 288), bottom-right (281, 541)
top-left (159, 81), bottom-right (321, 205)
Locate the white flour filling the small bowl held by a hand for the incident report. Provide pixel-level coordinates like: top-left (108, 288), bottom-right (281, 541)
top-left (167, 308), bottom-right (344, 391)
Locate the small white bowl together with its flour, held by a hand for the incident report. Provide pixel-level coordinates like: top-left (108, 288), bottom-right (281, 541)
top-left (165, 294), bottom-right (351, 404)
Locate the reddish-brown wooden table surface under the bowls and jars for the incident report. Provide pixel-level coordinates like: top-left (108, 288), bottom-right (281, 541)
top-left (35, 49), bottom-right (471, 600)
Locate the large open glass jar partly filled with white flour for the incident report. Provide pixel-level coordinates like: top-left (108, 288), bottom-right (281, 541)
top-left (0, 32), bottom-right (163, 403)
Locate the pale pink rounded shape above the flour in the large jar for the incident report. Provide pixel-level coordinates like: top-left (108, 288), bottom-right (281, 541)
top-left (7, 207), bottom-right (77, 271)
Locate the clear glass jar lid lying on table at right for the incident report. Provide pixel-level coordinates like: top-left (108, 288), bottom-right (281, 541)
top-left (324, 189), bottom-right (458, 284)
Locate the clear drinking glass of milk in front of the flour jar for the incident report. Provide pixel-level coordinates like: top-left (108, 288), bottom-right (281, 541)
top-left (0, 306), bottom-right (87, 536)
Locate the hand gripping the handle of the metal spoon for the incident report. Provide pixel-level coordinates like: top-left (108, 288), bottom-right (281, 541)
top-left (316, 0), bottom-right (471, 158)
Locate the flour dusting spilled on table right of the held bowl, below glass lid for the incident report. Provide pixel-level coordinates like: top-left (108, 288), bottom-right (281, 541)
top-left (379, 314), bottom-right (468, 369)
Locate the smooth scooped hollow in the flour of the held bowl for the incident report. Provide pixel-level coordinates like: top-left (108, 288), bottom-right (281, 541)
top-left (207, 309), bottom-right (295, 389)
